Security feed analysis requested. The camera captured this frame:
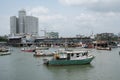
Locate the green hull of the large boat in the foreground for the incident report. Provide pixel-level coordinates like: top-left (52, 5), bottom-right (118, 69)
top-left (46, 56), bottom-right (94, 65)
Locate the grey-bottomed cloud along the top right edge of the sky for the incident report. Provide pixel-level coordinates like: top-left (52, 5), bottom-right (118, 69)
top-left (59, 0), bottom-right (120, 12)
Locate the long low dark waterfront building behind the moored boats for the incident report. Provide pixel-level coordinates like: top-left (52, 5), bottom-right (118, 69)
top-left (35, 37), bottom-right (92, 47)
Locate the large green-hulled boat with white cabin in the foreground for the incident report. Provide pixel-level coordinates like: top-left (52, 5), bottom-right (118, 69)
top-left (43, 51), bottom-right (94, 65)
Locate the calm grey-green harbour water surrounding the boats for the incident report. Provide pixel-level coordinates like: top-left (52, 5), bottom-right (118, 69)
top-left (0, 48), bottom-right (120, 80)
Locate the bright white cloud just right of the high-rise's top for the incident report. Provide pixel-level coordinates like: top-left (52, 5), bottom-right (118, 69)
top-left (27, 6), bottom-right (65, 22)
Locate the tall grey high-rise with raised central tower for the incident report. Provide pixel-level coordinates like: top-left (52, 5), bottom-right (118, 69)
top-left (10, 10), bottom-right (38, 35)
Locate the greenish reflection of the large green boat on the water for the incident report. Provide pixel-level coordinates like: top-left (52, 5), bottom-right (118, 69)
top-left (42, 64), bottom-right (94, 80)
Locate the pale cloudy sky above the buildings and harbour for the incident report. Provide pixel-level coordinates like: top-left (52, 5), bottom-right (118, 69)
top-left (0, 0), bottom-right (120, 37)
